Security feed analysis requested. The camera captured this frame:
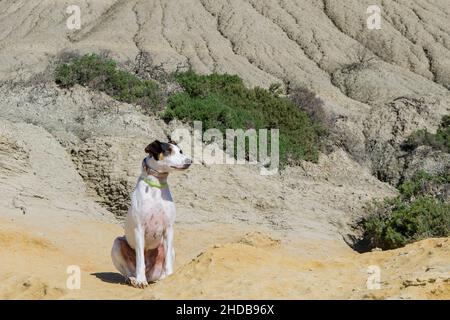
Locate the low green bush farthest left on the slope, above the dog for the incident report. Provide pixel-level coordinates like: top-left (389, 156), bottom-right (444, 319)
top-left (55, 54), bottom-right (162, 110)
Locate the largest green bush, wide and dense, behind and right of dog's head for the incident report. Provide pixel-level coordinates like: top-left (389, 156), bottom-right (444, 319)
top-left (163, 71), bottom-right (324, 164)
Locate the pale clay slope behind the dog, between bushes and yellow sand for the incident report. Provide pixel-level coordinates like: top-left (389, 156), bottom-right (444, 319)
top-left (0, 85), bottom-right (395, 239)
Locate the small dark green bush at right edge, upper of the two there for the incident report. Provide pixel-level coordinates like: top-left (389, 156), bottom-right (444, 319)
top-left (402, 115), bottom-right (450, 153)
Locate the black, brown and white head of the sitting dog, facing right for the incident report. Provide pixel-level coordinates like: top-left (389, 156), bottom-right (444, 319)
top-left (145, 140), bottom-right (192, 173)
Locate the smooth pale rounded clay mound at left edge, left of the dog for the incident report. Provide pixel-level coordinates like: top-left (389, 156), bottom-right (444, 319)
top-left (0, 118), bottom-right (110, 220)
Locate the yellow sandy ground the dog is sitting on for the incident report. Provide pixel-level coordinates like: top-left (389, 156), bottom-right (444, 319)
top-left (0, 211), bottom-right (450, 299)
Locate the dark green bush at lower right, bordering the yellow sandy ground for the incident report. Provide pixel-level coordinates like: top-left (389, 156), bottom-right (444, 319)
top-left (361, 172), bottom-right (450, 249)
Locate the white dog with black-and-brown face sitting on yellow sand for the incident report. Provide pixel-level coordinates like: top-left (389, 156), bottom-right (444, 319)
top-left (111, 140), bottom-right (192, 288)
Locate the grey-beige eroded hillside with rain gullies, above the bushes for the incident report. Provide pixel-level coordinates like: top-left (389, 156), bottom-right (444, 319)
top-left (0, 0), bottom-right (450, 172)
